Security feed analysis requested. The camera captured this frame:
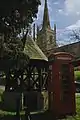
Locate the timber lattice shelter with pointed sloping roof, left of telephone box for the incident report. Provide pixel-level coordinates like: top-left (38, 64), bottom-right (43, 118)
top-left (0, 37), bottom-right (48, 110)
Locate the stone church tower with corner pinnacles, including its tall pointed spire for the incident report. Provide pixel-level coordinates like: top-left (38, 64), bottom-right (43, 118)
top-left (36, 0), bottom-right (56, 54)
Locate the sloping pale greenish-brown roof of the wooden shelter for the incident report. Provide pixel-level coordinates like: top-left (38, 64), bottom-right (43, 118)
top-left (24, 36), bottom-right (48, 61)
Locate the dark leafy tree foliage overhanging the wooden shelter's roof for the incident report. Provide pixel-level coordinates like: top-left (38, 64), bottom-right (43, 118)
top-left (0, 0), bottom-right (40, 69)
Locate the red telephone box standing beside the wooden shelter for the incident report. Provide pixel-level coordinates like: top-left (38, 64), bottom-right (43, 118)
top-left (48, 52), bottom-right (76, 116)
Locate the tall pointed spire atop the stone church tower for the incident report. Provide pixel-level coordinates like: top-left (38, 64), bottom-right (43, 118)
top-left (42, 0), bottom-right (50, 28)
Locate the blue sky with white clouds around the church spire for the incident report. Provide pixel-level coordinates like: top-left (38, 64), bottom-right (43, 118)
top-left (36, 0), bottom-right (80, 44)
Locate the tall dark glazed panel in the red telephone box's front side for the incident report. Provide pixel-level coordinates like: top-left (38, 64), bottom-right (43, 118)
top-left (61, 64), bottom-right (70, 102)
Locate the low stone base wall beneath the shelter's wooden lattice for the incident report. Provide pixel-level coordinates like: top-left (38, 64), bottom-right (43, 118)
top-left (2, 91), bottom-right (48, 112)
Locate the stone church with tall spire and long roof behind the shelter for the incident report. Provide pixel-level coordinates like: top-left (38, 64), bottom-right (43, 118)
top-left (33, 0), bottom-right (80, 59)
